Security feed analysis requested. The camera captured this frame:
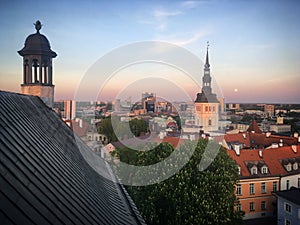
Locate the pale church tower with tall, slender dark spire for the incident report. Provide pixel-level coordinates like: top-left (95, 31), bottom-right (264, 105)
top-left (195, 43), bottom-right (220, 132)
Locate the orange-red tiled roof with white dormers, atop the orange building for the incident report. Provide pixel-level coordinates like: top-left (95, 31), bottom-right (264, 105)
top-left (227, 145), bottom-right (300, 177)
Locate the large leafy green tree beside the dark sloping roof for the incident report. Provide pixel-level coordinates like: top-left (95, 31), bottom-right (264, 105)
top-left (113, 140), bottom-right (242, 225)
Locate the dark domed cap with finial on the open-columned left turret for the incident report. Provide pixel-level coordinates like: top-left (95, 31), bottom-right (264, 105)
top-left (18, 21), bottom-right (57, 58)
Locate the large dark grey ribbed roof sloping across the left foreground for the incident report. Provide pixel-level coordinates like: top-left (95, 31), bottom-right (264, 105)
top-left (0, 91), bottom-right (144, 225)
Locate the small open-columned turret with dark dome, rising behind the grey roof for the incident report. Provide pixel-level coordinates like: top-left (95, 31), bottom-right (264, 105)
top-left (18, 21), bottom-right (57, 108)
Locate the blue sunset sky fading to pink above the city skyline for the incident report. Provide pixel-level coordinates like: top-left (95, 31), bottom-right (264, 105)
top-left (0, 0), bottom-right (300, 103)
